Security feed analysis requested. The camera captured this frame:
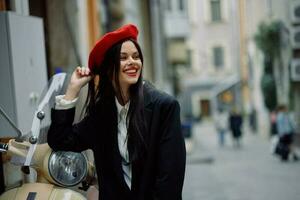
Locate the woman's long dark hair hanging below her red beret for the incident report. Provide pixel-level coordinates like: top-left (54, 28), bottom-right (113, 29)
top-left (86, 39), bottom-right (146, 162)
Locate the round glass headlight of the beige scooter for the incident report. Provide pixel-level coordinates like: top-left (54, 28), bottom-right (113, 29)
top-left (48, 151), bottom-right (87, 186)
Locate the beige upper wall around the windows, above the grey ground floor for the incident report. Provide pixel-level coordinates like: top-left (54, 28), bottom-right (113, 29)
top-left (188, 0), bottom-right (239, 76)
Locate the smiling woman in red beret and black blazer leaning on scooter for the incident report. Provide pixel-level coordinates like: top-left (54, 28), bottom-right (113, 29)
top-left (48, 24), bottom-right (185, 200)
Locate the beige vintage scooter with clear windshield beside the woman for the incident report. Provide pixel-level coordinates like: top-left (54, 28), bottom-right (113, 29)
top-left (0, 73), bottom-right (95, 200)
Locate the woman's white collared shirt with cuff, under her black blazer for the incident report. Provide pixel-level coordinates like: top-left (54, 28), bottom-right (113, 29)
top-left (55, 95), bottom-right (132, 189)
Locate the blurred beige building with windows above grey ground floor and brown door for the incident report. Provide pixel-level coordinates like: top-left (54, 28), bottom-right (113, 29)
top-left (181, 0), bottom-right (243, 120)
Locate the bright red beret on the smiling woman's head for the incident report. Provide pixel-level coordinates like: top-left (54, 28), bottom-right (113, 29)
top-left (89, 24), bottom-right (139, 70)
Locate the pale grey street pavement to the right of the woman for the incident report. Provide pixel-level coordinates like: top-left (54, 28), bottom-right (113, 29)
top-left (183, 122), bottom-right (300, 200)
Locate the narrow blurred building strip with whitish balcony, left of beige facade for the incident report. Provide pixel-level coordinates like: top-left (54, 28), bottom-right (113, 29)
top-left (162, 0), bottom-right (190, 96)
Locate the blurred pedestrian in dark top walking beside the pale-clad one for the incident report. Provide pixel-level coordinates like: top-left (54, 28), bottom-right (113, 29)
top-left (229, 108), bottom-right (243, 147)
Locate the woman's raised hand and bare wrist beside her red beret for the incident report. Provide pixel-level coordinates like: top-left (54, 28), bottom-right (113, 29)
top-left (64, 67), bottom-right (92, 100)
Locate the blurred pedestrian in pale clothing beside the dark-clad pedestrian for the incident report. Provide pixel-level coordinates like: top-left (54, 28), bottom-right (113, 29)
top-left (215, 108), bottom-right (228, 147)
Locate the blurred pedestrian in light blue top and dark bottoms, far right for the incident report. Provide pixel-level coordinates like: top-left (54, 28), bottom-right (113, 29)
top-left (276, 105), bottom-right (298, 161)
